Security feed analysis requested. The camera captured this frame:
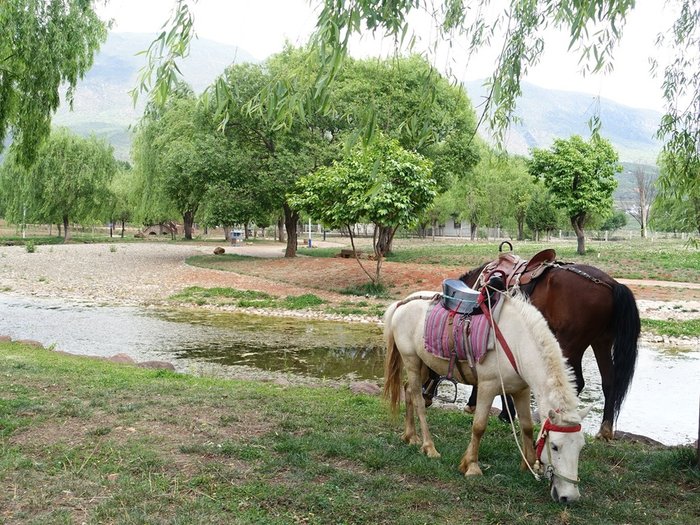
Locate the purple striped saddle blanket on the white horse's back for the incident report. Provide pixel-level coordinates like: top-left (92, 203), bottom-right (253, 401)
top-left (424, 301), bottom-right (502, 366)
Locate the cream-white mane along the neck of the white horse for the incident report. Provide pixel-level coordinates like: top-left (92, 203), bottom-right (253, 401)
top-left (506, 293), bottom-right (578, 412)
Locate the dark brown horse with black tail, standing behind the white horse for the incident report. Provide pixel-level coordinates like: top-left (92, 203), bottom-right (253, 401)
top-left (460, 256), bottom-right (641, 440)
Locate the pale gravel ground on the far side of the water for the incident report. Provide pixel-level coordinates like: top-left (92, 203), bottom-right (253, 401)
top-left (0, 243), bottom-right (352, 305)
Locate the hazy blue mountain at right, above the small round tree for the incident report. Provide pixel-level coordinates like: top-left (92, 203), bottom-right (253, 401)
top-left (465, 81), bottom-right (661, 165)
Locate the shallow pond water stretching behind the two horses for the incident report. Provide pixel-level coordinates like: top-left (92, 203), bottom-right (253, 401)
top-left (0, 294), bottom-right (700, 445)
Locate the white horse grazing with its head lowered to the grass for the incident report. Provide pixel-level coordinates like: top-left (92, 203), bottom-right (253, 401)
top-left (384, 292), bottom-right (590, 503)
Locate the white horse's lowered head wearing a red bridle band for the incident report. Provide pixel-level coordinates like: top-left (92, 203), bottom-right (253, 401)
top-left (537, 407), bottom-right (591, 503)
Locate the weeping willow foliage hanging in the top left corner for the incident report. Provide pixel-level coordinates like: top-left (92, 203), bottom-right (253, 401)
top-left (0, 0), bottom-right (107, 165)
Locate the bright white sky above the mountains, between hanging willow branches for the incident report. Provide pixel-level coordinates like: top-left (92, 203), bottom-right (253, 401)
top-left (99, 0), bottom-right (673, 111)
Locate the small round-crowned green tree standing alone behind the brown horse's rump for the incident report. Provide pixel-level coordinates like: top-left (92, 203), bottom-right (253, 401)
top-left (529, 135), bottom-right (622, 255)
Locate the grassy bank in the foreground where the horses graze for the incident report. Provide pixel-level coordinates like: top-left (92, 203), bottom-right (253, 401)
top-left (0, 343), bottom-right (700, 524)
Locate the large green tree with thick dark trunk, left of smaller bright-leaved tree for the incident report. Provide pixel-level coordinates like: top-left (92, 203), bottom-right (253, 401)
top-left (217, 52), bottom-right (339, 257)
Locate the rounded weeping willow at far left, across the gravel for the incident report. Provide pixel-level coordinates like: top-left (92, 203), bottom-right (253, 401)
top-left (2, 129), bottom-right (117, 240)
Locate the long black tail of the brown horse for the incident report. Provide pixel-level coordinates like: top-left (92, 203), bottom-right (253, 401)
top-left (613, 283), bottom-right (642, 420)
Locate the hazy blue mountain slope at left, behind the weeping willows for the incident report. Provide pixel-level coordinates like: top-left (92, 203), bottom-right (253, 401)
top-left (53, 33), bottom-right (258, 160)
